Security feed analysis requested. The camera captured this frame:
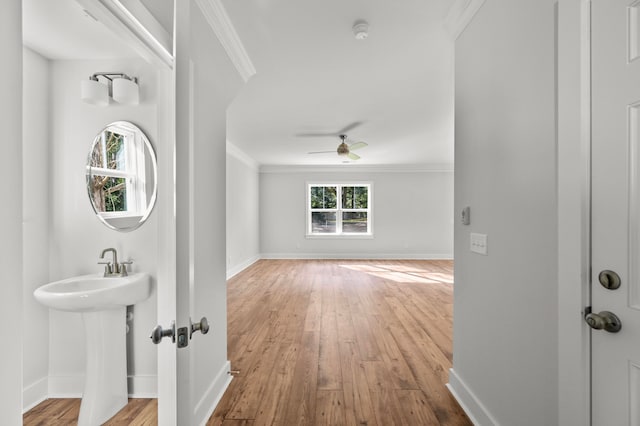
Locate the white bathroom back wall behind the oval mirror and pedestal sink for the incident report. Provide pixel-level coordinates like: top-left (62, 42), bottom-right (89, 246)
top-left (46, 59), bottom-right (162, 396)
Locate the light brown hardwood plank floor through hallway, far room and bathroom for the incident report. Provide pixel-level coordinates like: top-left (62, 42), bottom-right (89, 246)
top-left (24, 260), bottom-right (471, 426)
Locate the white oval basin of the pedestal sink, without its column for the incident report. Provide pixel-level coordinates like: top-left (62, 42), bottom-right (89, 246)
top-left (33, 272), bottom-right (151, 312)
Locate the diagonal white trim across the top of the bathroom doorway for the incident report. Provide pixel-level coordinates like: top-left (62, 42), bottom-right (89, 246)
top-left (76, 0), bottom-right (173, 69)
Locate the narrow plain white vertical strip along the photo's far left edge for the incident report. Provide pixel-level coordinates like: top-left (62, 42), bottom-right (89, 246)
top-left (0, 0), bottom-right (23, 425)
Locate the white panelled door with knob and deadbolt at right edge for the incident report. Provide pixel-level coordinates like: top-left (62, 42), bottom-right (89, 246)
top-left (591, 0), bottom-right (640, 426)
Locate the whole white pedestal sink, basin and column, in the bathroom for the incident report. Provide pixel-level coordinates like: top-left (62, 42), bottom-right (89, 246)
top-left (33, 273), bottom-right (151, 426)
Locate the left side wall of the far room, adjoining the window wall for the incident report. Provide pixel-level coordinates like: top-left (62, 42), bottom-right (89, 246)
top-left (227, 142), bottom-right (260, 279)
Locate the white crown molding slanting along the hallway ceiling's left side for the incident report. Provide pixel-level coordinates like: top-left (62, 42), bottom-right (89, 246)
top-left (195, 0), bottom-right (256, 83)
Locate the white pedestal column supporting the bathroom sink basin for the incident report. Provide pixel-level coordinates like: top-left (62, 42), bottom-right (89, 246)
top-left (78, 306), bottom-right (128, 426)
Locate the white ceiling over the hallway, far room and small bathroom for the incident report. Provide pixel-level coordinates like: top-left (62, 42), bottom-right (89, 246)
top-left (23, 0), bottom-right (453, 167)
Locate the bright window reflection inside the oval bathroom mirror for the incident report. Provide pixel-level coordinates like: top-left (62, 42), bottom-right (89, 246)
top-left (90, 122), bottom-right (147, 218)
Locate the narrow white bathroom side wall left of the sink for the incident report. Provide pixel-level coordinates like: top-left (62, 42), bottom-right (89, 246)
top-left (22, 48), bottom-right (51, 409)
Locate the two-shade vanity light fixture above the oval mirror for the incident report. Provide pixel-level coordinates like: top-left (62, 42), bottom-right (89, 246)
top-left (80, 72), bottom-right (140, 106)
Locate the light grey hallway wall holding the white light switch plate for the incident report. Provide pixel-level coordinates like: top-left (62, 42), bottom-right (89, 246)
top-left (450, 0), bottom-right (559, 426)
